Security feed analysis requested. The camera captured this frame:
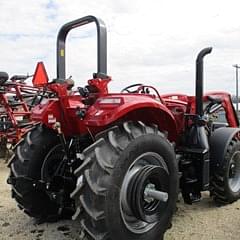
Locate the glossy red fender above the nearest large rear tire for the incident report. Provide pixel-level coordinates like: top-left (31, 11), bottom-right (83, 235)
top-left (84, 96), bottom-right (177, 141)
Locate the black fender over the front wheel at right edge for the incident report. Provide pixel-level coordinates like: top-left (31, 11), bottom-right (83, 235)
top-left (210, 127), bottom-right (240, 168)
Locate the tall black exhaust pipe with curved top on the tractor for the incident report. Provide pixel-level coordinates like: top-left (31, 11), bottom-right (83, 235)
top-left (196, 47), bottom-right (212, 116)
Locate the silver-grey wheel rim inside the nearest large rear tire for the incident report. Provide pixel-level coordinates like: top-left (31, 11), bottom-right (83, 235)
top-left (120, 152), bottom-right (169, 234)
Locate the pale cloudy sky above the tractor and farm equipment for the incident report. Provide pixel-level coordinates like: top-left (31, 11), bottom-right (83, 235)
top-left (0, 0), bottom-right (240, 94)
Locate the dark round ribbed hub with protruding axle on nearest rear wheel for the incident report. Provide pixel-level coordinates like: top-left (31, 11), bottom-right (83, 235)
top-left (127, 165), bottom-right (168, 223)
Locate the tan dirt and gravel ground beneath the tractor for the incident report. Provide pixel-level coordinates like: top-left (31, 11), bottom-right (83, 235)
top-left (0, 160), bottom-right (240, 240)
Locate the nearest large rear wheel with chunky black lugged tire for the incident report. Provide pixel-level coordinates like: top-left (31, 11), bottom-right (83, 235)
top-left (72, 122), bottom-right (178, 240)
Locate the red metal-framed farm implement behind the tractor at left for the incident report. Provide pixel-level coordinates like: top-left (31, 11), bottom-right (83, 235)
top-left (0, 72), bottom-right (52, 157)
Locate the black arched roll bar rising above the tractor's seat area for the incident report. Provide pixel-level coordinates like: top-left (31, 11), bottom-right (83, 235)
top-left (57, 16), bottom-right (107, 82)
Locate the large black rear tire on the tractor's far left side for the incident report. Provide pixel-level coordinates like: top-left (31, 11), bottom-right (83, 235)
top-left (8, 125), bottom-right (73, 221)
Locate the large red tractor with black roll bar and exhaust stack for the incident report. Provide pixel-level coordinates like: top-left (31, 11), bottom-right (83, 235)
top-left (8, 16), bottom-right (240, 240)
